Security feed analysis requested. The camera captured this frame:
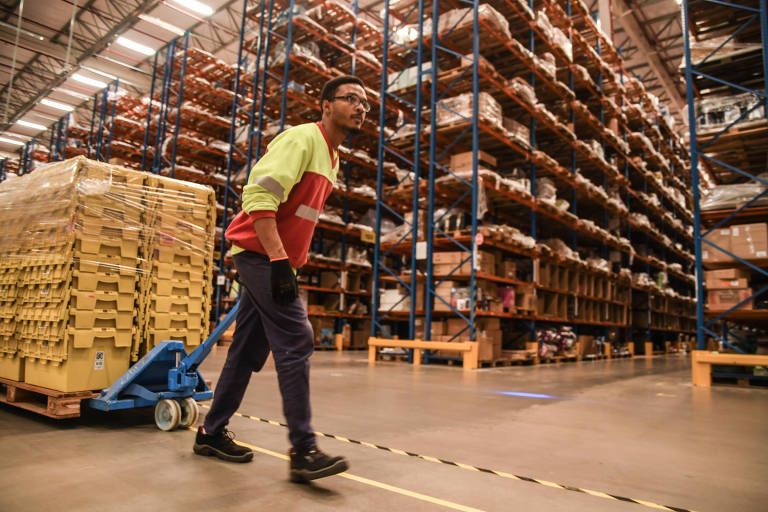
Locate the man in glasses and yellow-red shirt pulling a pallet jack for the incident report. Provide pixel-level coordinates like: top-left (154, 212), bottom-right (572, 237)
top-left (193, 76), bottom-right (370, 482)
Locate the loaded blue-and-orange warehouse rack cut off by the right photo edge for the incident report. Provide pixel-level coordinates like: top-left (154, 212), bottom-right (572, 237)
top-left (683, 0), bottom-right (768, 358)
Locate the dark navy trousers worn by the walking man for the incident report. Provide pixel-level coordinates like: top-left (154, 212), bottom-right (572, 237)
top-left (203, 251), bottom-right (315, 451)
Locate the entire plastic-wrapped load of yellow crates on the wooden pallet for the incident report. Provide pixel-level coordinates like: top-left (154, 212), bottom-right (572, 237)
top-left (0, 157), bottom-right (215, 392)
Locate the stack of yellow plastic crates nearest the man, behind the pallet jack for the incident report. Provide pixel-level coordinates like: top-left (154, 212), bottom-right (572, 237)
top-left (132, 176), bottom-right (216, 359)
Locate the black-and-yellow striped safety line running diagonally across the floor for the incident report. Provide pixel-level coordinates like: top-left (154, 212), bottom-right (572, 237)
top-left (201, 404), bottom-right (695, 512)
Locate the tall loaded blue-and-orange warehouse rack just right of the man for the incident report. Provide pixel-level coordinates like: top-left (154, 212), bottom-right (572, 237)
top-left (374, 1), bottom-right (693, 364)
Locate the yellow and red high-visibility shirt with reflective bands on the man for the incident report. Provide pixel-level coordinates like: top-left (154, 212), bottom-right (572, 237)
top-left (225, 122), bottom-right (339, 268)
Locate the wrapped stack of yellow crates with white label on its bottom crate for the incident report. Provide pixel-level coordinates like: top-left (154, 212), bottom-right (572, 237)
top-left (16, 157), bottom-right (144, 391)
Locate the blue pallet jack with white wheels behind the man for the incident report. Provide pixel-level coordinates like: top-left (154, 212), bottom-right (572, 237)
top-left (87, 304), bottom-right (238, 432)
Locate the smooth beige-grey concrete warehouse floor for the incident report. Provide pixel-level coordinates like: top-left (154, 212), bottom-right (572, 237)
top-left (0, 349), bottom-right (768, 512)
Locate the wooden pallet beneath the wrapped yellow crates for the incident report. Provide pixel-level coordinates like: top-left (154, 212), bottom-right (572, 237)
top-left (0, 378), bottom-right (98, 420)
